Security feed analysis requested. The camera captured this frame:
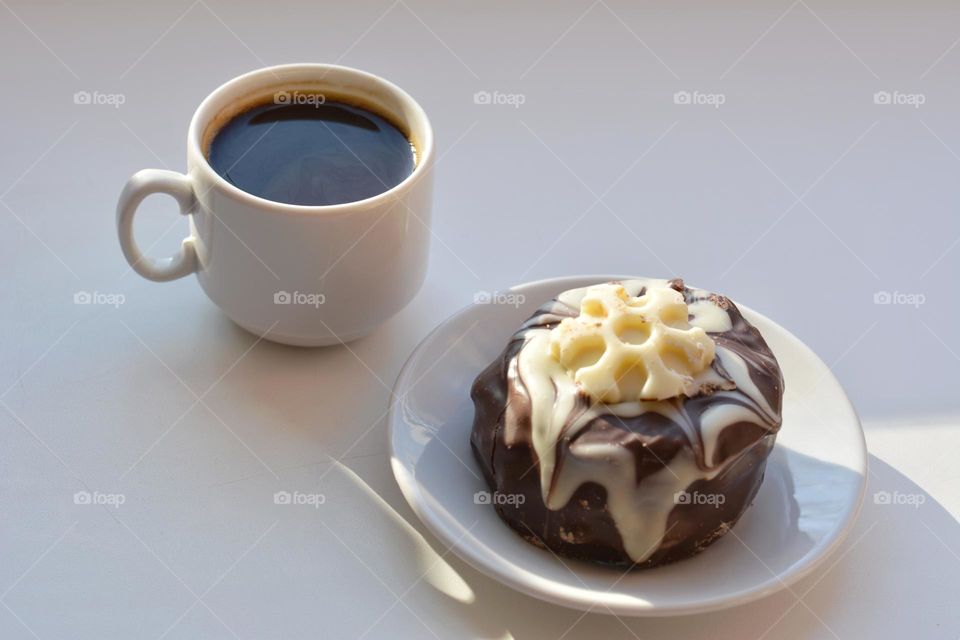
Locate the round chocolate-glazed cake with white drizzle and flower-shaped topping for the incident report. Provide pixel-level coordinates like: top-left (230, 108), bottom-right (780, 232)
top-left (471, 279), bottom-right (783, 567)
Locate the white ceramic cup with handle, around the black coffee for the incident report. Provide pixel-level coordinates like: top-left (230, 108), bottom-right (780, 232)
top-left (117, 64), bottom-right (434, 346)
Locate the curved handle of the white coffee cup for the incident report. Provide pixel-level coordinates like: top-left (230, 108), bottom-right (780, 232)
top-left (117, 169), bottom-right (198, 282)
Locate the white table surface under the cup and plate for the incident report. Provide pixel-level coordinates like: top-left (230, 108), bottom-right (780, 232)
top-left (0, 0), bottom-right (960, 640)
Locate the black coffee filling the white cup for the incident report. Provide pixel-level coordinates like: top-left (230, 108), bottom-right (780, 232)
top-left (209, 94), bottom-right (416, 205)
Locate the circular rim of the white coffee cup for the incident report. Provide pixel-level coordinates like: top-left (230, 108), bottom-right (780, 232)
top-left (187, 62), bottom-right (434, 215)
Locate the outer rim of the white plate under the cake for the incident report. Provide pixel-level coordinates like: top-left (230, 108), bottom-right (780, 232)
top-left (387, 274), bottom-right (869, 617)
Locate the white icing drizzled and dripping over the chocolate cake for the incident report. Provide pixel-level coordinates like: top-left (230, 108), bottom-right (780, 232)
top-left (505, 279), bottom-right (776, 562)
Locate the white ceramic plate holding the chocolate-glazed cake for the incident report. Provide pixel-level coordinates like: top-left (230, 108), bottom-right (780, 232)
top-left (390, 276), bottom-right (867, 616)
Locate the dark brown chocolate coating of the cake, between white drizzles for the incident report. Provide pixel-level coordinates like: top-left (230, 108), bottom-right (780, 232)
top-left (471, 280), bottom-right (783, 567)
